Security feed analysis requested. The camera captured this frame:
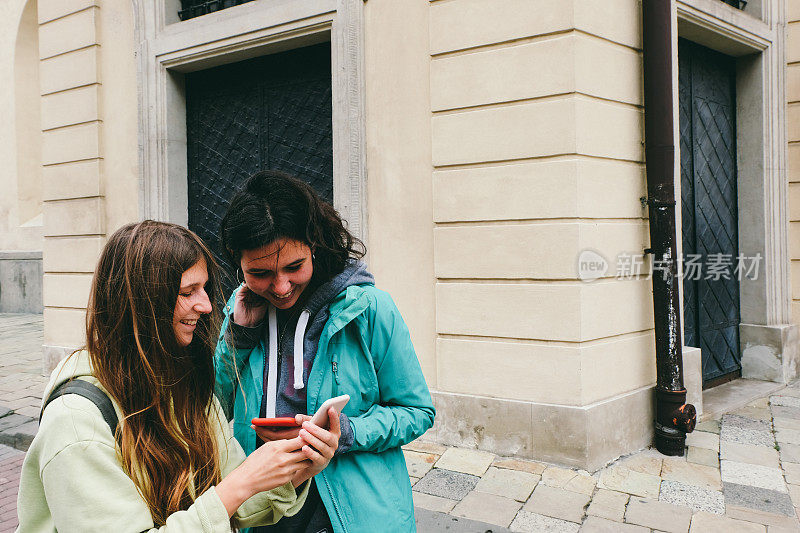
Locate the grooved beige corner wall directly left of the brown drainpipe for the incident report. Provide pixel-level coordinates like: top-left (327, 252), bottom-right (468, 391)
top-left (430, 0), bottom-right (655, 406)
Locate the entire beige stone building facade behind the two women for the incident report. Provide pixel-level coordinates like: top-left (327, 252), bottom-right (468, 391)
top-left (0, 0), bottom-right (800, 470)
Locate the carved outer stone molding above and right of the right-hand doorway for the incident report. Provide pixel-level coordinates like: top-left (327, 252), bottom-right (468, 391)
top-left (675, 0), bottom-right (791, 325)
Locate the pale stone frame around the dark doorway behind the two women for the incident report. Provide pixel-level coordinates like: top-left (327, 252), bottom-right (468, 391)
top-left (132, 0), bottom-right (367, 241)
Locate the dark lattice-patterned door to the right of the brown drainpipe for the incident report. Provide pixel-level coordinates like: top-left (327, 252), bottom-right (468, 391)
top-left (678, 39), bottom-right (741, 385)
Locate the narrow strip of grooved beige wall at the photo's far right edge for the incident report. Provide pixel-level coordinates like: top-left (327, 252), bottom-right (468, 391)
top-left (786, 0), bottom-right (800, 323)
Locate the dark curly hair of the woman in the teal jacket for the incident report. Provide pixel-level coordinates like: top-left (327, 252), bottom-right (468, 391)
top-left (220, 170), bottom-right (366, 283)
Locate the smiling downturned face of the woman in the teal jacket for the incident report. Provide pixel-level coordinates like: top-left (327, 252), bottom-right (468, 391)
top-left (241, 238), bottom-right (314, 309)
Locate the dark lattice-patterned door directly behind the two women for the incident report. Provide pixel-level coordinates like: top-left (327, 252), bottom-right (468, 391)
top-left (186, 43), bottom-right (333, 293)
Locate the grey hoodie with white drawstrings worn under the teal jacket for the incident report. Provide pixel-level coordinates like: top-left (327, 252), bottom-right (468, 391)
top-left (225, 260), bottom-right (375, 454)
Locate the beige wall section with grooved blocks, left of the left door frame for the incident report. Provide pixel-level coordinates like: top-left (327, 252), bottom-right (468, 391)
top-left (39, 0), bottom-right (138, 362)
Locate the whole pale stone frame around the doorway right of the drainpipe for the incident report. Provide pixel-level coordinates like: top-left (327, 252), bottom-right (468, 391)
top-left (673, 0), bottom-right (797, 383)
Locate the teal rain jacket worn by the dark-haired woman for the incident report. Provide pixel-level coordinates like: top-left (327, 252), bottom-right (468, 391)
top-left (215, 285), bottom-right (435, 533)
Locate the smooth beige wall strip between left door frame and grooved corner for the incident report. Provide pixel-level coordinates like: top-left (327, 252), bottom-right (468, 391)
top-left (364, 0), bottom-right (437, 387)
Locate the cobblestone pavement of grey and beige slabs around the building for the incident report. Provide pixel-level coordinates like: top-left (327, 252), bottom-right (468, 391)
top-left (0, 314), bottom-right (800, 533)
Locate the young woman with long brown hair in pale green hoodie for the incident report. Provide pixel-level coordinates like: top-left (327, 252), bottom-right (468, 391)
top-left (18, 221), bottom-right (338, 533)
